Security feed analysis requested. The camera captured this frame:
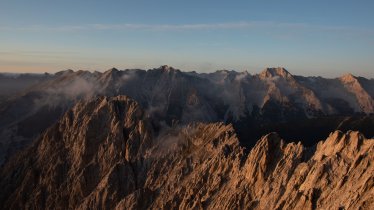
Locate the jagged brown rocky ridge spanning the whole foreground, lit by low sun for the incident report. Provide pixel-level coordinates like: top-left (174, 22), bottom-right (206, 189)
top-left (0, 96), bottom-right (374, 209)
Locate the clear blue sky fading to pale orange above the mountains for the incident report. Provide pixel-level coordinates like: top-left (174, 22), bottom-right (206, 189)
top-left (0, 0), bottom-right (374, 78)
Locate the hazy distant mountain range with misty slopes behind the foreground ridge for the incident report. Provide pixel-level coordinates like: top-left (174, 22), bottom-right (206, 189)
top-left (0, 66), bottom-right (374, 162)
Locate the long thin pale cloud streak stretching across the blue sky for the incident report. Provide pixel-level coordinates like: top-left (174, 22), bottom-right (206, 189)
top-left (0, 21), bottom-right (374, 35)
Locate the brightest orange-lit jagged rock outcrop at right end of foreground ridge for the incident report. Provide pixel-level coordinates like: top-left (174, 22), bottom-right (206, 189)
top-left (246, 131), bottom-right (374, 209)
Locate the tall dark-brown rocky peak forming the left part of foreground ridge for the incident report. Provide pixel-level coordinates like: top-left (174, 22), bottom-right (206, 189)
top-left (0, 96), bottom-right (152, 209)
